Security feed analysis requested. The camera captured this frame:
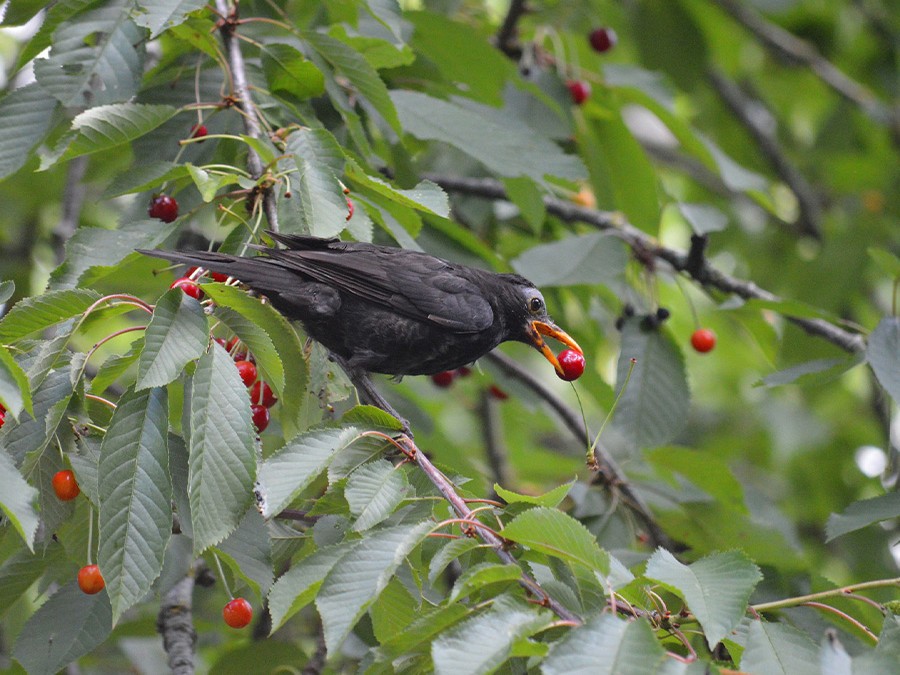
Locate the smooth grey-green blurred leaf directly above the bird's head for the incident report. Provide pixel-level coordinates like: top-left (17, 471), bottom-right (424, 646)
top-left (512, 232), bottom-right (628, 287)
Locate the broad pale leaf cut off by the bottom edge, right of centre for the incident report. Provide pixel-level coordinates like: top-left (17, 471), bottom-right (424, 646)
top-left (541, 614), bottom-right (667, 675)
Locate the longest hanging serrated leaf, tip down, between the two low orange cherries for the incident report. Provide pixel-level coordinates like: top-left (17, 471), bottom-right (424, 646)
top-left (98, 387), bottom-right (172, 624)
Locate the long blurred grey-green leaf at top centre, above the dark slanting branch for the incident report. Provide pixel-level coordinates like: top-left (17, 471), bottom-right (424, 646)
top-left (391, 90), bottom-right (587, 184)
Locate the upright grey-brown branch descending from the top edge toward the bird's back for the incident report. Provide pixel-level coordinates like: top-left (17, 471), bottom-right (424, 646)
top-left (216, 0), bottom-right (278, 232)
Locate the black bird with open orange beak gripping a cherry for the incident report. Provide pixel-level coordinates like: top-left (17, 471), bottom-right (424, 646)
top-left (140, 232), bottom-right (582, 376)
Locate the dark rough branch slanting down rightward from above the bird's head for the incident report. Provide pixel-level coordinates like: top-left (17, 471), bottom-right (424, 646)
top-left (425, 174), bottom-right (865, 354)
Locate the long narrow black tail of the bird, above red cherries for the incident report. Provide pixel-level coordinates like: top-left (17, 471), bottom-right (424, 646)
top-left (137, 249), bottom-right (298, 294)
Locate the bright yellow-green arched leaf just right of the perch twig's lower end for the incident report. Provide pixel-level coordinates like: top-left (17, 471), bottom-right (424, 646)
top-left (503, 506), bottom-right (609, 574)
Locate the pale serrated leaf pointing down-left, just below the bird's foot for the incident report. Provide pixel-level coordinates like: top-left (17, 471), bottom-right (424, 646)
top-left (258, 427), bottom-right (372, 518)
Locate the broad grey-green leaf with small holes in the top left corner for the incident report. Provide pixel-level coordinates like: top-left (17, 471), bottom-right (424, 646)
top-left (34, 2), bottom-right (143, 108)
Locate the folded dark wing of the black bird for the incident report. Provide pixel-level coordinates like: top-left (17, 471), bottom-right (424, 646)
top-left (267, 244), bottom-right (494, 333)
